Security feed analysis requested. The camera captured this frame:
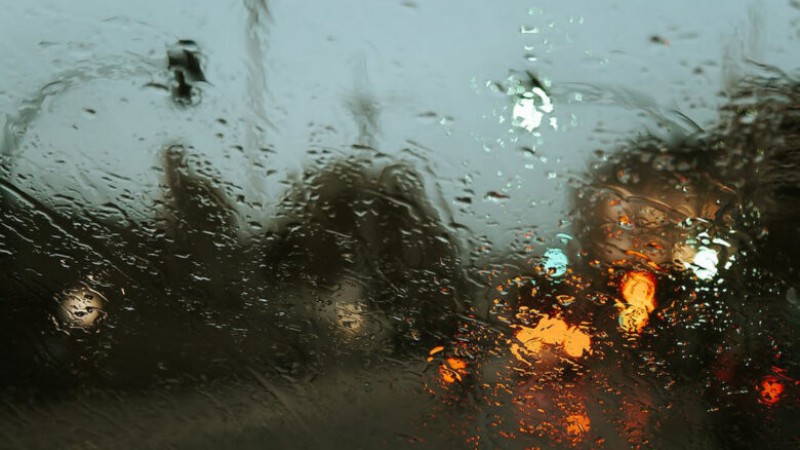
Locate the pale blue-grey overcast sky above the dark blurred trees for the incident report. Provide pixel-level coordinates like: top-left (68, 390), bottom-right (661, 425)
top-left (0, 0), bottom-right (800, 243)
